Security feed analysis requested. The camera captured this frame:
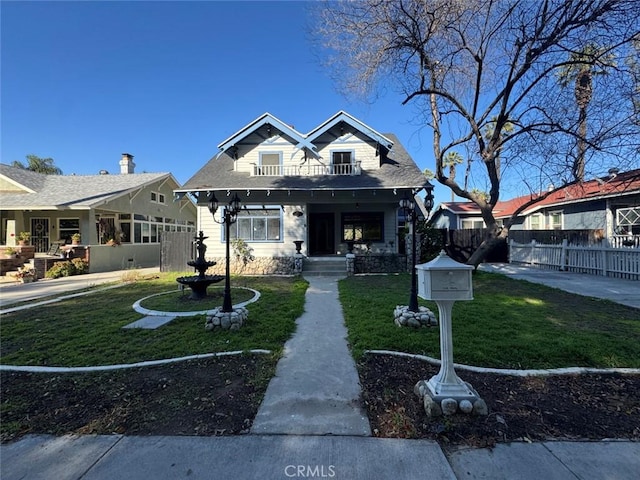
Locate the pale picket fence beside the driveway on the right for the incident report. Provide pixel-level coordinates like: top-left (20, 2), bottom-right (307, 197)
top-left (509, 240), bottom-right (640, 280)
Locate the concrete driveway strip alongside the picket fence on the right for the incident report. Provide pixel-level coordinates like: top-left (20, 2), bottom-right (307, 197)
top-left (479, 263), bottom-right (640, 308)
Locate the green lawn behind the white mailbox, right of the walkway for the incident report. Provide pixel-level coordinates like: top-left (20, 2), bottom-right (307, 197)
top-left (339, 272), bottom-right (640, 368)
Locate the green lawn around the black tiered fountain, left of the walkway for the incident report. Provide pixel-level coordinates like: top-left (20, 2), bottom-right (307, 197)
top-left (0, 275), bottom-right (307, 366)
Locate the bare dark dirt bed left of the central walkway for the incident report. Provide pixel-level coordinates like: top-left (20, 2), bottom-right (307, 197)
top-left (0, 355), bottom-right (276, 442)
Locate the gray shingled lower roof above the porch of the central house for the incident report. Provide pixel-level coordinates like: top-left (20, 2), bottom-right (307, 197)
top-left (176, 134), bottom-right (429, 192)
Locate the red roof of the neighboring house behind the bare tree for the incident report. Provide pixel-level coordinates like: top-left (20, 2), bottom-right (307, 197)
top-left (430, 169), bottom-right (640, 218)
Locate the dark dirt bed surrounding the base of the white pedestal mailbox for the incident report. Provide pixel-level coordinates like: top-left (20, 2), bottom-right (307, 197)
top-left (359, 355), bottom-right (640, 447)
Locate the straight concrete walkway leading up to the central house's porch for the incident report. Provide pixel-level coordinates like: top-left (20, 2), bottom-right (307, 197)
top-left (251, 276), bottom-right (371, 436)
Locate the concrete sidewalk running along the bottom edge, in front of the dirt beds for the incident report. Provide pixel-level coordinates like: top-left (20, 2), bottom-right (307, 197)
top-left (0, 435), bottom-right (640, 480)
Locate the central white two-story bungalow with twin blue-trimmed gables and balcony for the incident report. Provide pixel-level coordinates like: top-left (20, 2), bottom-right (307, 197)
top-left (176, 111), bottom-right (432, 273)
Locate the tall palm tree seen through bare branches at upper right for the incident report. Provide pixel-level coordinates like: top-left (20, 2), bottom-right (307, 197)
top-left (558, 44), bottom-right (615, 182)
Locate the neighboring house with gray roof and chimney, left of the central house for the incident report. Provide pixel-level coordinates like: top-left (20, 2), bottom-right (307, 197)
top-left (0, 153), bottom-right (196, 271)
